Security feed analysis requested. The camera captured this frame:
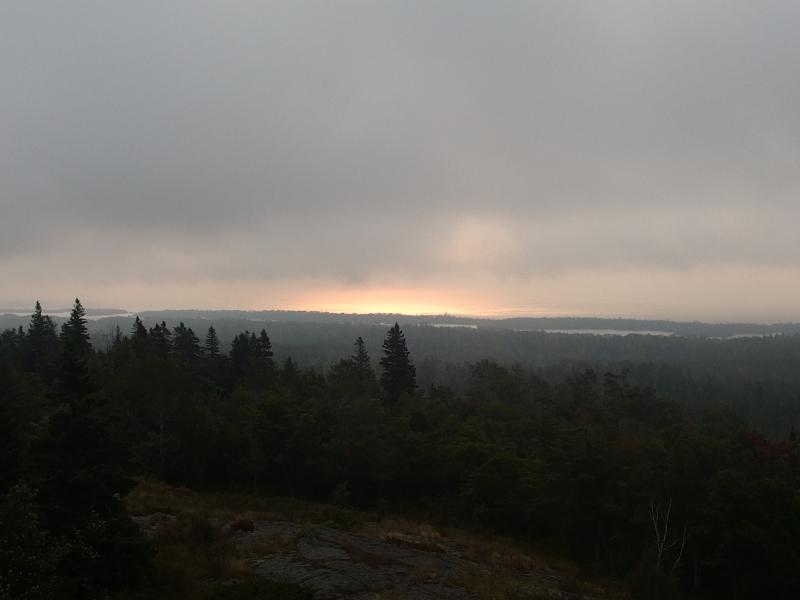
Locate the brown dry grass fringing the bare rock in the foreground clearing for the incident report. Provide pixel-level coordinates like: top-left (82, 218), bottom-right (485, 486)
top-left (126, 479), bottom-right (611, 600)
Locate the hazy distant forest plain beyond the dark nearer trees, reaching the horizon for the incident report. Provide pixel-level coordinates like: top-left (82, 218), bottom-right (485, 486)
top-left (0, 309), bottom-right (800, 440)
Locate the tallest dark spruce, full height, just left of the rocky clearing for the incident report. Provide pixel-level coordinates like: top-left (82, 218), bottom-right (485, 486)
top-left (38, 299), bottom-right (149, 598)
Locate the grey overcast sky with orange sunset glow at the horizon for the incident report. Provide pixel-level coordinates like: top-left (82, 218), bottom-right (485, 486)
top-left (0, 0), bottom-right (800, 321)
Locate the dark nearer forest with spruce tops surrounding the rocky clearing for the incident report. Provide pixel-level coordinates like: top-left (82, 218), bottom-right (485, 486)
top-left (0, 301), bottom-right (800, 599)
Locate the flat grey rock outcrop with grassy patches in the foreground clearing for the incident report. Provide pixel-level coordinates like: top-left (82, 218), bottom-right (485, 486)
top-left (133, 513), bottom-right (591, 600)
